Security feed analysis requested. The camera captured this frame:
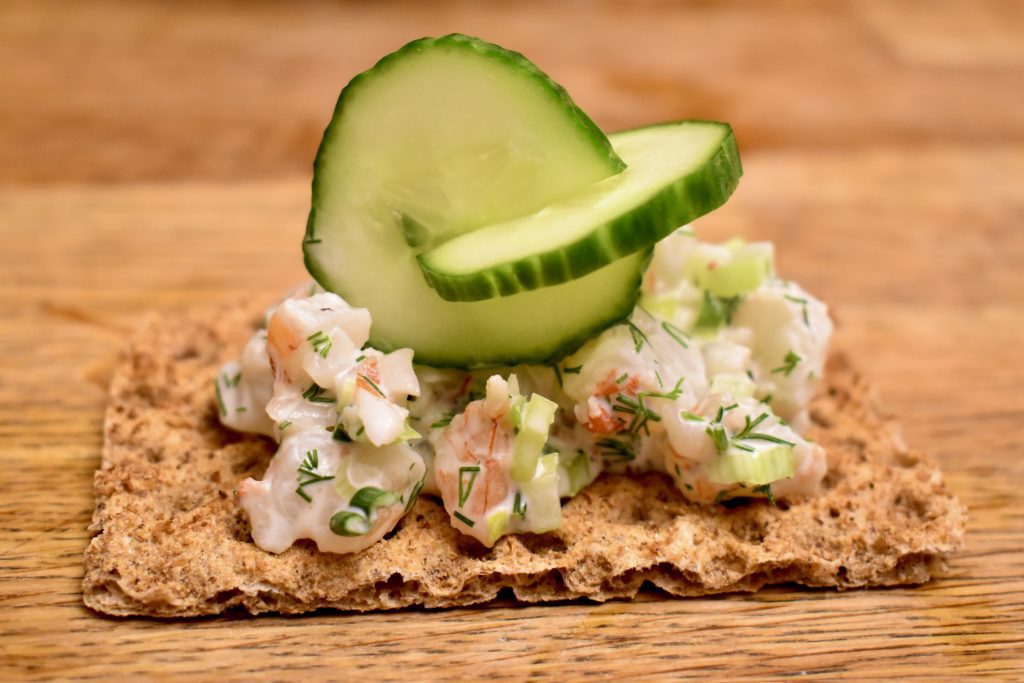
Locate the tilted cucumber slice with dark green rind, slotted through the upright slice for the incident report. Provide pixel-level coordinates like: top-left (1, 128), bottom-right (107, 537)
top-left (419, 121), bottom-right (742, 301)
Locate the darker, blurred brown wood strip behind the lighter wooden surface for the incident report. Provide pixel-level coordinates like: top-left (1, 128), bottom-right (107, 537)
top-left (0, 0), bottom-right (1024, 182)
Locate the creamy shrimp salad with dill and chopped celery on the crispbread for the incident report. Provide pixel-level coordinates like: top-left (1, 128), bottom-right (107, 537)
top-left (215, 228), bottom-right (831, 553)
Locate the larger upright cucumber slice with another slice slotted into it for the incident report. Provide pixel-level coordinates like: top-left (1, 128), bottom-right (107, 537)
top-left (303, 36), bottom-right (647, 368)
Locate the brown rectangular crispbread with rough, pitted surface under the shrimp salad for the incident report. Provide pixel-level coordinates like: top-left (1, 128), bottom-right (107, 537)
top-left (83, 307), bottom-right (967, 616)
